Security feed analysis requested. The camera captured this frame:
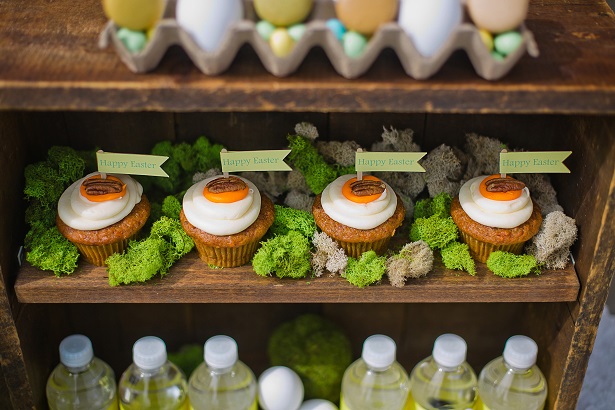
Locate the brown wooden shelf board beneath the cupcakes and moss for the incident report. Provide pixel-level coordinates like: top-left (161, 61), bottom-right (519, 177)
top-left (15, 251), bottom-right (579, 303)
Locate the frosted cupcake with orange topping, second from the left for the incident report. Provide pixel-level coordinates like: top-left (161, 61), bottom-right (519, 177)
top-left (180, 176), bottom-right (274, 268)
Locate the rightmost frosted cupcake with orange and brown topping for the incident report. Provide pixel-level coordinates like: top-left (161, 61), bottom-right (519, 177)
top-left (451, 174), bottom-right (542, 262)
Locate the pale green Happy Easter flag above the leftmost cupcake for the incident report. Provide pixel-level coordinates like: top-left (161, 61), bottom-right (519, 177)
top-left (96, 152), bottom-right (169, 178)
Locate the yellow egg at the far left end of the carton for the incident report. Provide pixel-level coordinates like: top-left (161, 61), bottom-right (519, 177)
top-left (103, 0), bottom-right (165, 31)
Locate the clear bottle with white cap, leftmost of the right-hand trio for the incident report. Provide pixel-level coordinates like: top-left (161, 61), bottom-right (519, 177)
top-left (340, 335), bottom-right (409, 410)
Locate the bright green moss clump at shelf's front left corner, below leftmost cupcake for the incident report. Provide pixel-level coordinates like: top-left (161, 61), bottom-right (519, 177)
top-left (26, 226), bottom-right (79, 276)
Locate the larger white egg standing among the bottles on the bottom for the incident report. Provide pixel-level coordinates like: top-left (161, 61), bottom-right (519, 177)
top-left (258, 366), bottom-right (303, 410)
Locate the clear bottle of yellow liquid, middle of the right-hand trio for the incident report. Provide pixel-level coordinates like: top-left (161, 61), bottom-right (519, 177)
top-left (410, 333), bottom-right (477, 410)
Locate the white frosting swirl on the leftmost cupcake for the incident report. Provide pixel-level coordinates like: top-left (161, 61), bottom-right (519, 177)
top-left (58, 172), bottom-right (143, 231)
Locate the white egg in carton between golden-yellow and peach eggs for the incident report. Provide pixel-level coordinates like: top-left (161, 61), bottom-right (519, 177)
top-left (398, 0), bottom-right (462, 57)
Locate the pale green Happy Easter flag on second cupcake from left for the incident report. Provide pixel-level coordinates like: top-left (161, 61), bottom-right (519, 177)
top-left (220, 149), bottom-right (292, 172)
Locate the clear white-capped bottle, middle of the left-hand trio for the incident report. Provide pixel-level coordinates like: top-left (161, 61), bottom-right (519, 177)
top-left (119, 336), bottom-right (188, 410)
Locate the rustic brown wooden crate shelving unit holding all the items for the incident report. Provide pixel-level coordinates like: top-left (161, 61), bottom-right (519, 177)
top-left (0, 0), bottom-right (615, 409)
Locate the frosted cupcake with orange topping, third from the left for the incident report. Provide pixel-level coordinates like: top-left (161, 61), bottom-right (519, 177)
top-left (312, 175), bottom-right (406, 258)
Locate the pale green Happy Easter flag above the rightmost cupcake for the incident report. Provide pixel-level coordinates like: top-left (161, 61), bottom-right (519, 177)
top-left (500, 151), bottom-right (572, 174)
